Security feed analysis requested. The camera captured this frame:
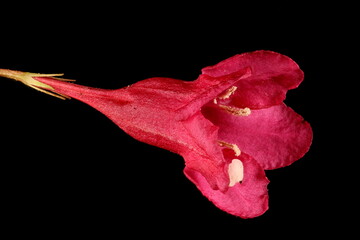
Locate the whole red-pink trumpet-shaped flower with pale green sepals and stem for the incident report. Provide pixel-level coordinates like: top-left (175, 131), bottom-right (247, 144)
top-left (0, 51), bottom-right (312, 218)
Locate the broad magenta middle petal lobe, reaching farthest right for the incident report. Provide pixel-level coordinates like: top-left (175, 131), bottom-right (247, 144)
top-left (203, 104), bottom-right (312, 169)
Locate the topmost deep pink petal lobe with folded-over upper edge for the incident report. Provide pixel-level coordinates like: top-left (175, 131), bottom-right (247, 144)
top-left (202, 51), bottom-right (304, 109)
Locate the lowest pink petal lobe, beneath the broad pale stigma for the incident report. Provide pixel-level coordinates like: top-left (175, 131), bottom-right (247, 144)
top-left (184, 154), bottom-right (269, 218)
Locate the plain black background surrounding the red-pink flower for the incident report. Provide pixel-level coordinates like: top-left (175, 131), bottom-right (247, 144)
top-left (0, 3), bottom-right (356, 237)
